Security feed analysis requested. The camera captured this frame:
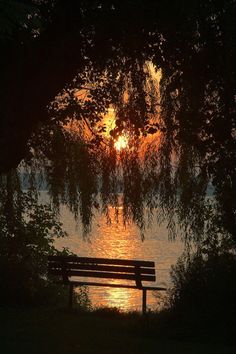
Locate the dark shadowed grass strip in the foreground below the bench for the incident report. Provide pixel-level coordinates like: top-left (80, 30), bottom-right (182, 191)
top-left (0, 308), bottom-right (236, 354)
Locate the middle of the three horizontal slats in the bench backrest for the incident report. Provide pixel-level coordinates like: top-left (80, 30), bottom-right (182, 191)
top-left (49, 262), bottom-right (155, 274)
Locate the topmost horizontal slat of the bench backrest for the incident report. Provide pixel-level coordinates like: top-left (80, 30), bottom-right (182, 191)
top-left (48, 256), bottom-right (155, 267)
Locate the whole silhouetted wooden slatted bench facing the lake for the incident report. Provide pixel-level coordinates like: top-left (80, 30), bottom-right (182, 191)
top-left (48, 256), bottom-right (166, 314)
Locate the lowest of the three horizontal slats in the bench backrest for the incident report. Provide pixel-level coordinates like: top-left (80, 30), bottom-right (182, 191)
top-left (49, 269), bottom-right (156, 281)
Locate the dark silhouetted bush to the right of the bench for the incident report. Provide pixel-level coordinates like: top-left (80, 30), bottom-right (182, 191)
top-left (170, 250), bottom-right (236, 321)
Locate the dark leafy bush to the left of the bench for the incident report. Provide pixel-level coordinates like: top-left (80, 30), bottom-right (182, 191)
top-left (0, 192), bottom-right (66, 304)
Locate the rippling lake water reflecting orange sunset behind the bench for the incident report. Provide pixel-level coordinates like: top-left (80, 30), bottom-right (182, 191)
top-left (56, 201), bottom-right (183, 311)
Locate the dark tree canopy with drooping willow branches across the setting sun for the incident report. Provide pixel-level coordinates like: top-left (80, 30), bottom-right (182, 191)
top-left (0, 0), bottom-right (236, 240)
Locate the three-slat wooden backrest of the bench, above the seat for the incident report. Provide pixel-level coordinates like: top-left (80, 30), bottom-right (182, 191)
top-left (48, 256), bottom-right (156, 287)
